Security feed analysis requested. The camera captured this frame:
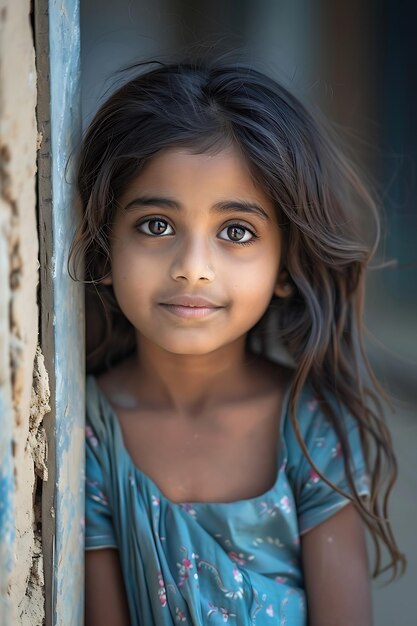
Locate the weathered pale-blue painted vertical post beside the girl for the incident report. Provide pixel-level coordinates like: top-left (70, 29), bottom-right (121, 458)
top-left (49, 0), bottom-right (85, 626)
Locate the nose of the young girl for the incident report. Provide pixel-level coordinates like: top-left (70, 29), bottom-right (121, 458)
top-left (171, 235), bottom-right (215, 284)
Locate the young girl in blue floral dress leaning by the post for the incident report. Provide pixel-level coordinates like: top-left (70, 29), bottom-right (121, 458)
top-left (72, 63), bottom-right (403, 626)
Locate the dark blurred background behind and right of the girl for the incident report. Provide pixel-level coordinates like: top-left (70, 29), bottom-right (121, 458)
top-left (80, 0), bottom-right (417, 626)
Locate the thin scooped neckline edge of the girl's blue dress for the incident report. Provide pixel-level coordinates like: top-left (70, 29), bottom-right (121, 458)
top-left (87, 374), bottom-right (291, 509)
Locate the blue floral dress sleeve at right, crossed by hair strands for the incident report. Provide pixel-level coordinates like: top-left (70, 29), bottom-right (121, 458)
top-left (289, 390), bottom-right (369, 534)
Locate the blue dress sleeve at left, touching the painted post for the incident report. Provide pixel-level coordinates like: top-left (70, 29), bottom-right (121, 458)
top-left (85, 424), bottom-right (117, 550)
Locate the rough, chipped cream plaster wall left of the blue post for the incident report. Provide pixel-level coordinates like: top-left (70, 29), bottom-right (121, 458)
top-left (0, 0), bottom-right (48, 626)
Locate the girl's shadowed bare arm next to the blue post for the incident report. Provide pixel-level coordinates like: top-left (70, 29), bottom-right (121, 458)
top-left (85, 548), bottom-right (130, 626)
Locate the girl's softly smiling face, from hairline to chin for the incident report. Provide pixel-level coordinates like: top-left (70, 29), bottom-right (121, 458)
top-left (104, 143), bottom-right (285, 355)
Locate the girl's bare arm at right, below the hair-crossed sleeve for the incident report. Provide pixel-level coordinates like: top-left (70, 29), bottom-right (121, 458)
top-left (301, 504), bottom-right (372, 626)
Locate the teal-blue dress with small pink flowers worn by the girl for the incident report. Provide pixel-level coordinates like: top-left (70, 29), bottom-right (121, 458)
top-left (85, 377), bottom-right (369, 626)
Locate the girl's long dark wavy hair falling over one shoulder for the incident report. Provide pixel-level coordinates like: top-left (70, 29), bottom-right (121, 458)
top-left (70, 61), bottom-right (405, 575)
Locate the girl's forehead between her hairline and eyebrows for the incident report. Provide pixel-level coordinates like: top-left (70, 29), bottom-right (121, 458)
top-left (121, 147), bottom-right (274, 214)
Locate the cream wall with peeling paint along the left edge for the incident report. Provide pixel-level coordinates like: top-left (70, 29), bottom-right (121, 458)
top-left (0, 0), bottom-right (46, 626)
